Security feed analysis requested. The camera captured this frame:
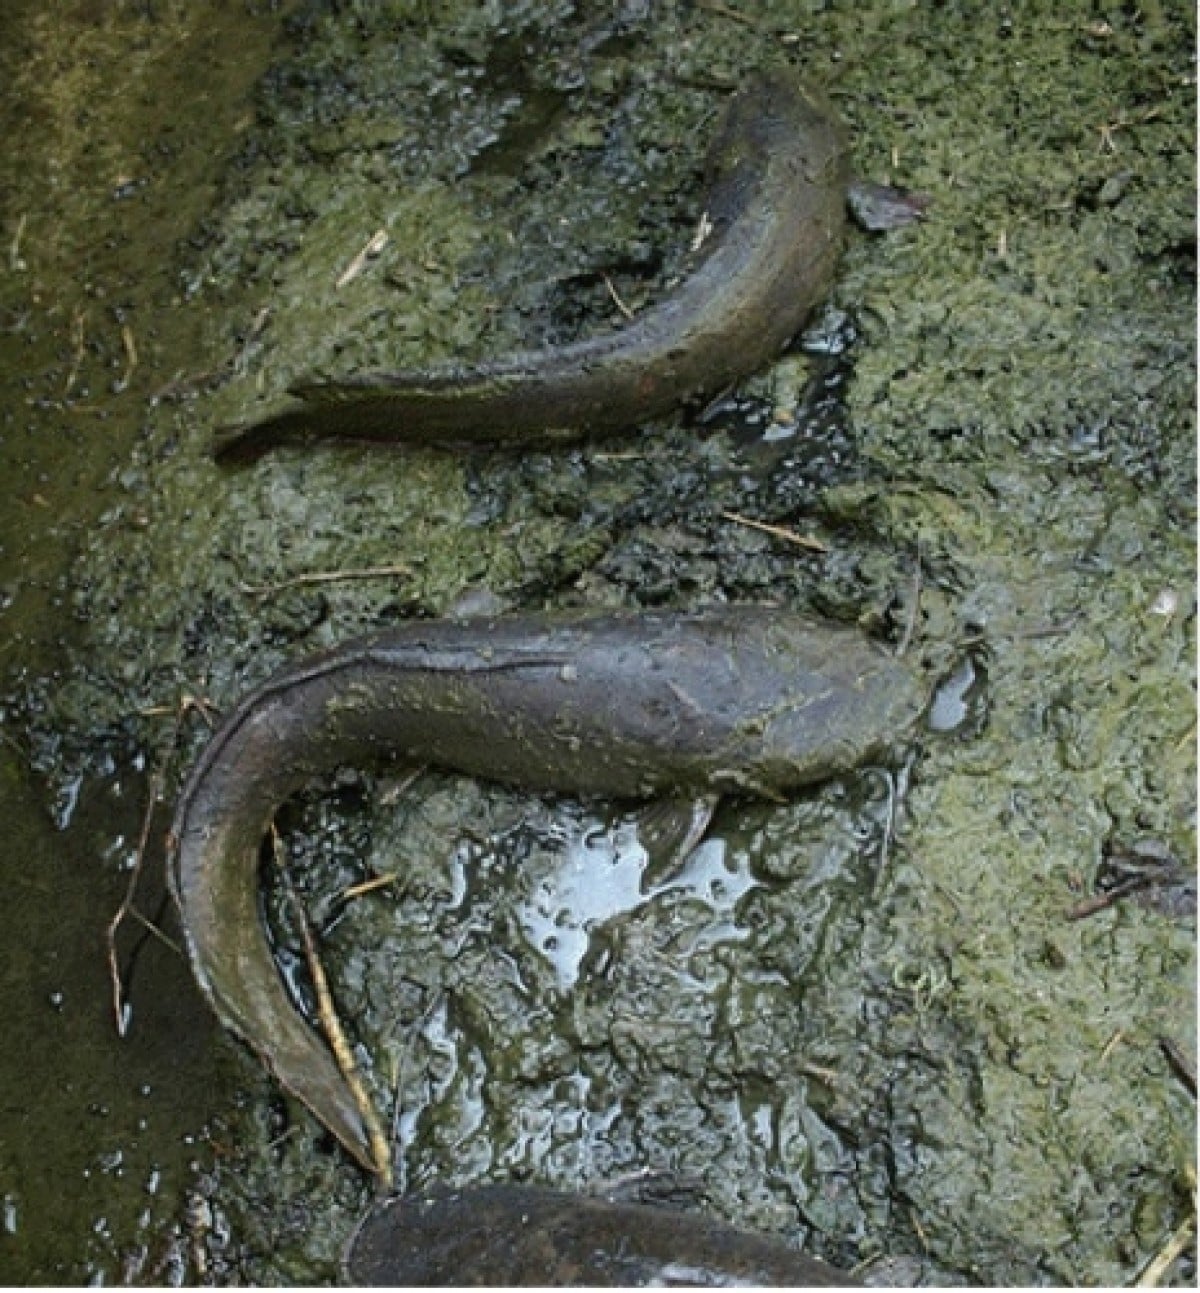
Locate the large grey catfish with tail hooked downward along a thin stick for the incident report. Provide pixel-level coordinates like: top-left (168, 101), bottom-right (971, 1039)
top-left (172, 605), bottom-right (923, 1168)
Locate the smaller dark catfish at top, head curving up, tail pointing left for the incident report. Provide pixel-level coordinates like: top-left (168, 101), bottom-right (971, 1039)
top-left (213, 74), bottom-right (848, 462)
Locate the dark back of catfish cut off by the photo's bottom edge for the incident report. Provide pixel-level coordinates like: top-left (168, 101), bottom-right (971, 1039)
top-left (344, 1186), bottom-right (859, 1288)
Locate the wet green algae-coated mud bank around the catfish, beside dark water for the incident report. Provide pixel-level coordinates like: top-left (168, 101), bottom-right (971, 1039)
top-left (7, 0), bottom-right (1195, 1285)
